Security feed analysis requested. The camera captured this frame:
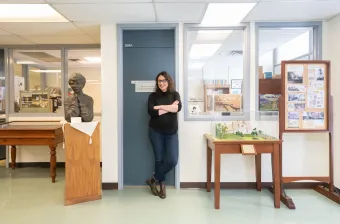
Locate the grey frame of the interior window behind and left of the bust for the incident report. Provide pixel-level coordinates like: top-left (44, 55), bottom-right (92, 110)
top-left (0, 44), bottom-right (100, 119)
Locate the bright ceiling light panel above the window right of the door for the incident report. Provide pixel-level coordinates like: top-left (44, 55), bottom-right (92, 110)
top-left (201, 3), bottom-right (257, 26)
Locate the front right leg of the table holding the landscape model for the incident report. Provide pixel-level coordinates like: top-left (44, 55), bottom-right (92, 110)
top-left (272, 144), bottom-right (281, 208)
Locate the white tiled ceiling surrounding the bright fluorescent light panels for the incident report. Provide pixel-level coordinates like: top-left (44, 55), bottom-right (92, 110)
top-left (0, 0), bottom-right (340, 45)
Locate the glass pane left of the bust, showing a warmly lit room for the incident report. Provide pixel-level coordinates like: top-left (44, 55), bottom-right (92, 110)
top-left (13, 50), bottom-right (63, 113)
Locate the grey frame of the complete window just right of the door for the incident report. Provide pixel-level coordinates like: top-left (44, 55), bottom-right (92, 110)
top-left (182, 23), bottom-right (250, 121)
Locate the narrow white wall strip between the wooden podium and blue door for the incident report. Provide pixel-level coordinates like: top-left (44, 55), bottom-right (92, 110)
top-left (100, 24), bottom-right (118, 183)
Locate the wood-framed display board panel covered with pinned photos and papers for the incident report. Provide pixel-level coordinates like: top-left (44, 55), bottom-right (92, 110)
top-left (282, 61), bottom-right (329, 131)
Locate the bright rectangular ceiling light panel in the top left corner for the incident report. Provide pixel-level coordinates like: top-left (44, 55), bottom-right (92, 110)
top-left (0, 4), bottom-right (69, 22)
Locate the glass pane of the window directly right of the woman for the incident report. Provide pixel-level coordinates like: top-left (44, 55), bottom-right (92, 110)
top-left (186, 29), bottom-right (244, 118)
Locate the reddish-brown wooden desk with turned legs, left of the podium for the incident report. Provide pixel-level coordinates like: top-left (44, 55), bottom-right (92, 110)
top-left (0, 122), bottom-right (64, 183)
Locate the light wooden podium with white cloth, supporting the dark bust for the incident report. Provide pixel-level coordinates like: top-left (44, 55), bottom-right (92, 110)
top-left (64, 122), bottom-right (102, 205)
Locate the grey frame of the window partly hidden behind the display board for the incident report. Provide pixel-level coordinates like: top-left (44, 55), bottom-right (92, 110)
top-left (254, 22), bottom-right (322, 121)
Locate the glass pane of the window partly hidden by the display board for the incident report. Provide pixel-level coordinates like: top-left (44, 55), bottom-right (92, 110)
top-left (258, 27), bottom-right (314, 115)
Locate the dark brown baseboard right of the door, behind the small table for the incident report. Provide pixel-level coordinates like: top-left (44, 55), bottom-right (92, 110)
top-left (180, 182), bottom-right (323, 189)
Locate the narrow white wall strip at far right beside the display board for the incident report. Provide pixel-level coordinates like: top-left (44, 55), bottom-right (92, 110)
top-left (323, 16), bottom-right (340, 188)
